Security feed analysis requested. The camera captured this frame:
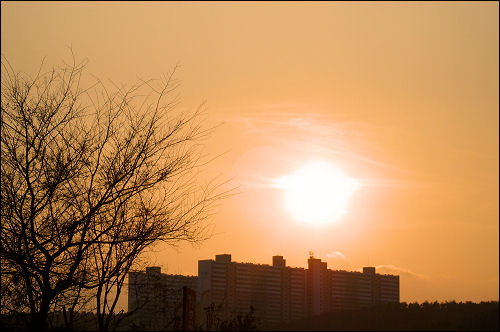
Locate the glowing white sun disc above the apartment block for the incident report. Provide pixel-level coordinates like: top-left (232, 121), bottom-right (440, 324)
top-left (277, 162), bottom-right (359, 224)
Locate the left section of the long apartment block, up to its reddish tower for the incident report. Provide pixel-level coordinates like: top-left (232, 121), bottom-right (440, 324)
top-left (198, 254), bottom-right (307, 326)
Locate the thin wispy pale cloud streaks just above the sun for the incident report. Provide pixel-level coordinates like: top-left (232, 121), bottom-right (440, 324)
top-left (225, 104), bottom-right (414, 178)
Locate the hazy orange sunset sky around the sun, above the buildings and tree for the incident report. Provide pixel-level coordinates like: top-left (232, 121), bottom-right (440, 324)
top-left (1, 1), bottom-right (499, 302)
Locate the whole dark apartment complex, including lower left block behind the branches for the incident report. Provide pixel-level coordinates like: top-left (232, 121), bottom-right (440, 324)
top-left (128, 254), bottom-right (399, 330)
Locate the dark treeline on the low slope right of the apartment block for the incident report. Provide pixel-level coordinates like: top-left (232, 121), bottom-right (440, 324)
top-left (273, 301), bottom-right (499, 331)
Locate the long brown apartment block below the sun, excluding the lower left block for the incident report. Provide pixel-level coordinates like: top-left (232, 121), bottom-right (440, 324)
top-left (198, 254), bottom-right (399, 327)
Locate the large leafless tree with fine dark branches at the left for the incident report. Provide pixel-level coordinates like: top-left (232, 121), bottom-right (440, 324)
top-left (1, 54), bottom-right (227, 330)
